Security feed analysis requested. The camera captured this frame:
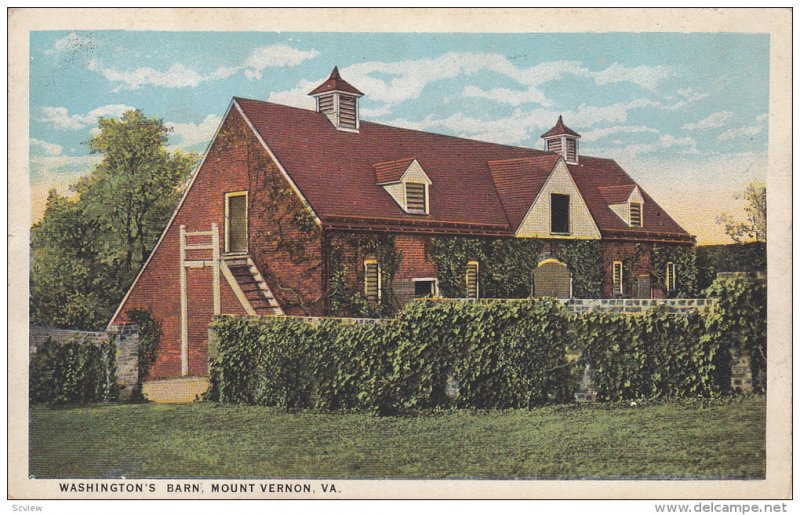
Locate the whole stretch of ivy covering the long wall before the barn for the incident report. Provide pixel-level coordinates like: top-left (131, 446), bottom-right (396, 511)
top-left (208, 290), bottom-right (766, 413)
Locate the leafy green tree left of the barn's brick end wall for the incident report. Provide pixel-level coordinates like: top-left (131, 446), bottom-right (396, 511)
top-left (30, 110), bottom-right (198, 329)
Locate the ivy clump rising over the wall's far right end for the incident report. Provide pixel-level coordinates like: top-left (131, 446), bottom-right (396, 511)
top-left (704, 276), bottom-right (767, 391)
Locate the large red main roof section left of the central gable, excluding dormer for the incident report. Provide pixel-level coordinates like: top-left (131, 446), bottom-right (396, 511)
top-left (236, 98), bottom-right (544, 233)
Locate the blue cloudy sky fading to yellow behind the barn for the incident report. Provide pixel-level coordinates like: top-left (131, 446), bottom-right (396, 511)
top-left (30, 31), bottom-right (769, 243)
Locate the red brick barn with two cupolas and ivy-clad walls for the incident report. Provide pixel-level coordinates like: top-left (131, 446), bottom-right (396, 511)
top-left (110, 68), bottom-right (694, 379)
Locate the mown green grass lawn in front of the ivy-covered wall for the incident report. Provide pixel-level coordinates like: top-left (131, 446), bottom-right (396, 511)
top-left (30, 396), bottom-right (766, 479)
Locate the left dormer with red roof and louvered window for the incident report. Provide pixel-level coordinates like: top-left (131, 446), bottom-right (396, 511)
top-left (372, 157), bottom-right (433, 215)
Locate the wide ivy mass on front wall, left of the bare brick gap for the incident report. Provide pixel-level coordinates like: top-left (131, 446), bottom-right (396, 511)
top-left (208, 299), bottom-right (572, 413)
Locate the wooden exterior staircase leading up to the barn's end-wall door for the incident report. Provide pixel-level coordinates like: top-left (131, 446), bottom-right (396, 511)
top-left (222, 256), bottom-right (283, 316)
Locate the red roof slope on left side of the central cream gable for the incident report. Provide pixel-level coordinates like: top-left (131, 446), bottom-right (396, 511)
top-left (487, 152), bottom-right (558, 230)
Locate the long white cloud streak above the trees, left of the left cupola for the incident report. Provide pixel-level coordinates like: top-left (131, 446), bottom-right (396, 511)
top-left (89, 43), bottom-right (319, 91)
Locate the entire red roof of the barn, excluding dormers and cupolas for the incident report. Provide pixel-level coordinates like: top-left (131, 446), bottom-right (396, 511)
top-left (235, 98), bottom-right (691, 241)
